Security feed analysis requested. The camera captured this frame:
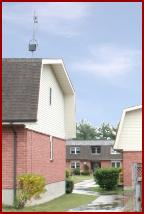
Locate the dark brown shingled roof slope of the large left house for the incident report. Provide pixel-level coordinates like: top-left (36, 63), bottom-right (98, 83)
top-left (2, 58), bottom-right (42, 122)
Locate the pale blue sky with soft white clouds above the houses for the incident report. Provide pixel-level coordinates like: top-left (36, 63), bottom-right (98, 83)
top-left (2, 2), bottom-right (142, 126)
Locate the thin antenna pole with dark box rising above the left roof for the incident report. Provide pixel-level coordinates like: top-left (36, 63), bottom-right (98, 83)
top-left (29, 11), bottom-right (38, 57)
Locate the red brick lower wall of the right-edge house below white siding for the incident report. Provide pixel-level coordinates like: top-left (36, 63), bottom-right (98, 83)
top-left (123, 152), bottom-right (142, 187)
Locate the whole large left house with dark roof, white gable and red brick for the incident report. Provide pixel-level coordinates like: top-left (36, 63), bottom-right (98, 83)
top-left (2, 59), bottom-right (76, 205)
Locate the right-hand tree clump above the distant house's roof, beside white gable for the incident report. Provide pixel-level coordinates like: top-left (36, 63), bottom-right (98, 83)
top-left (97, 123), bottom-right (118, 140)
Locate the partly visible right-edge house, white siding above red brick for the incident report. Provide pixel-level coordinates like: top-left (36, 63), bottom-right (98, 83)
top-left (114, 105), bottom-right (142, 189)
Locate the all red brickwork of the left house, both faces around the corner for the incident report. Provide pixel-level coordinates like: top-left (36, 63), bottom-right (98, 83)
top-left (2, 127), bottom-right (65, 189)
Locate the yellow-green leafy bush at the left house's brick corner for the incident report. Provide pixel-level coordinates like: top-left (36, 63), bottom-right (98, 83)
top-left (15, 174), bottom-right (46, 208)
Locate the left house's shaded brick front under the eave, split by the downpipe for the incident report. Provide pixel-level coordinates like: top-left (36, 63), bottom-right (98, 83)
top-left (2, 127), bottom-right (26, 188)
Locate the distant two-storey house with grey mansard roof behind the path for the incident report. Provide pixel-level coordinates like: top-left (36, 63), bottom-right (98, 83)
top-left (66, 140), bottom-right (122, 170)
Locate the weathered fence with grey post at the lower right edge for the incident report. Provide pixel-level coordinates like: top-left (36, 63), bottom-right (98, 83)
top-left (133, 163), bottom-right (142, 212)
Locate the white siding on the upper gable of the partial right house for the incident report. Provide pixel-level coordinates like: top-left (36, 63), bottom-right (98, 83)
top-left (115, 109), bottom-right (142, 151)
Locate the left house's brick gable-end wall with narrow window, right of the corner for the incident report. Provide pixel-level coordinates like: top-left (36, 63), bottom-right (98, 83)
top-left (27, 130), bottom-right (66, 183)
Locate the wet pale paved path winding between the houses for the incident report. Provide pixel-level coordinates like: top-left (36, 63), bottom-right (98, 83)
top-left (69, 179), bottom-right (124, 212)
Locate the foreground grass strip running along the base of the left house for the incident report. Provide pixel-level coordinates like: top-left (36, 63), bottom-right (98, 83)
top-left (3, 193), bottom-right (96, 212)
